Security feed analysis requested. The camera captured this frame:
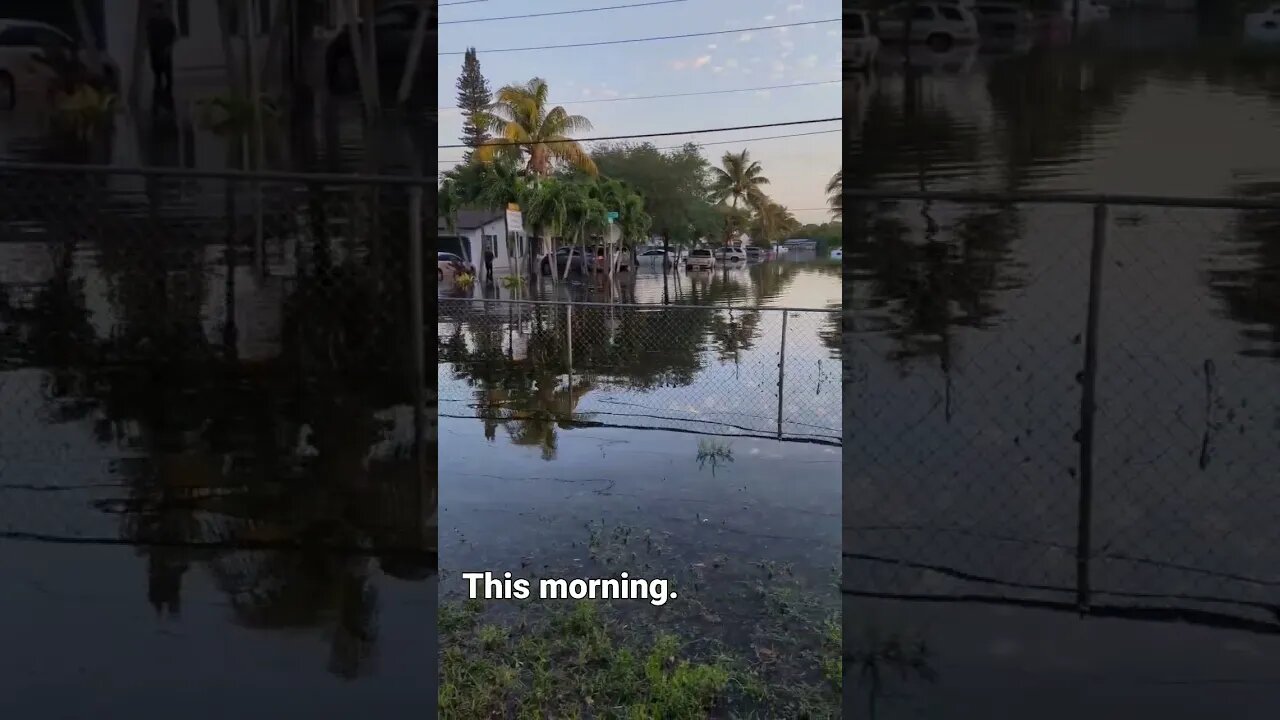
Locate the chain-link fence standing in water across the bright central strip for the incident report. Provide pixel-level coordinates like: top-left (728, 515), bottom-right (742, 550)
top-left (438, 297), bottom-right (840, 445)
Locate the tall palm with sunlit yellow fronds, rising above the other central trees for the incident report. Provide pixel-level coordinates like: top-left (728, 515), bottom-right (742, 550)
top-left (476, 77), bottom-right (598, 176)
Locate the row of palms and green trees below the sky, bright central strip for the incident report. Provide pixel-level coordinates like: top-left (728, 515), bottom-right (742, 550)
top-left (439, 47), bottom-right (842, 270)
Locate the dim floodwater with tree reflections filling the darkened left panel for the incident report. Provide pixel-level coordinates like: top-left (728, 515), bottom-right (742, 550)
top-left (0, 103), bottom-right (436, 719)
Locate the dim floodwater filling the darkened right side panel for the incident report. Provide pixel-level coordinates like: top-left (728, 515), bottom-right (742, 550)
top-left (844, 15), bottom-right (1280, 719)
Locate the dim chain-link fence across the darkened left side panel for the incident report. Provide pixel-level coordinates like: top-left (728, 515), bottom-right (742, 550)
top-left (0, 164), bottom-right (435, 566)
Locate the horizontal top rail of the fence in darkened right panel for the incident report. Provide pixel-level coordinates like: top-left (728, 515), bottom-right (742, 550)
top-left (844, 187), bottom-right (1280, 210)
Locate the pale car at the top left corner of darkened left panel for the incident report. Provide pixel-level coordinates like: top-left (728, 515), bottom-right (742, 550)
top-left (0, 18), bottom-right (118, 110)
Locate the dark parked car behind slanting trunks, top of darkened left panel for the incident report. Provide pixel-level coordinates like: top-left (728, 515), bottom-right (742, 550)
top-left (325, 3), bottom-right (435, 95)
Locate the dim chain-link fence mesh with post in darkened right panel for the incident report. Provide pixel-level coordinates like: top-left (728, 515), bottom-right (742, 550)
top-left (844, 192), bottom-right (1280, 632)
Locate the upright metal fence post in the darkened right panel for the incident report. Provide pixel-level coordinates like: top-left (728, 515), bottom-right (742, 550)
top-left (1075, 202), bottom-right (1107, 614)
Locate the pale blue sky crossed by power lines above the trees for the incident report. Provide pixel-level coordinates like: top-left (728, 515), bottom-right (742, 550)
top-left (438, 0), bottom-right (841, 222)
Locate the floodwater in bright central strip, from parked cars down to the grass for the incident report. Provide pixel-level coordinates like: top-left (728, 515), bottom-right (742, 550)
top-left (438, 260), bottom-right (841, 707)
